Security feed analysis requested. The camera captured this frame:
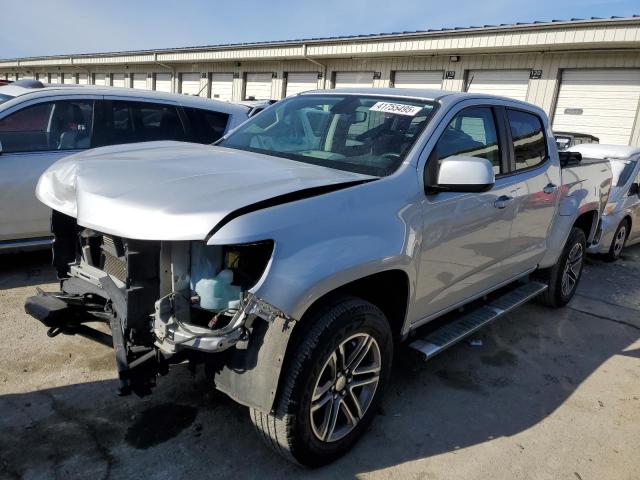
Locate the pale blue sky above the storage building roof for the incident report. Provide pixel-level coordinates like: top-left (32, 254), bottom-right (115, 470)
top-left (0, 0), bottom-right (640, 59)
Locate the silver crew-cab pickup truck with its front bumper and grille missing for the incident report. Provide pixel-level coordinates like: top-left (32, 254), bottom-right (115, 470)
top-left (26, 89), bottom-right (611, 466)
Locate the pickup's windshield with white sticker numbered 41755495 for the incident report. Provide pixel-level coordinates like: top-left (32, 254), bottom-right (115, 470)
top-left (219, 94), bottom-right (434, 176)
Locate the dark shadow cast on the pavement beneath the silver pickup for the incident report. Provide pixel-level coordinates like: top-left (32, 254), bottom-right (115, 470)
top-left (0, 249), bottom-right (640, 479)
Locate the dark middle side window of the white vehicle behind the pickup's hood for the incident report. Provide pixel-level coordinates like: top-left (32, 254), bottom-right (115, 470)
top-left (97, 100), bottom-right (186, 146)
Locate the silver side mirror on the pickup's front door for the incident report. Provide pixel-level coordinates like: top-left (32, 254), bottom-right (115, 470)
top-left (427, 155), bottom-right (496, 193)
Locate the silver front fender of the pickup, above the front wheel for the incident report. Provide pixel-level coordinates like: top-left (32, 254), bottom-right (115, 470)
top-left (208, 169), bottom-right (422, 319)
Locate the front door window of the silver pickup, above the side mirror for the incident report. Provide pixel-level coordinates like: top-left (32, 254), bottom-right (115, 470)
top-left (435, 107), bottom-right (502, 175)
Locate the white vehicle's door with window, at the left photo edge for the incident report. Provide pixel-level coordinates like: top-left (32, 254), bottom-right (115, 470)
top-left (0, 96), bottom-right (101, 241)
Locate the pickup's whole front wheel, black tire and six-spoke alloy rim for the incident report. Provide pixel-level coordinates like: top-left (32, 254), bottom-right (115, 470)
top-left (251, 297), bottom-right (393, 467)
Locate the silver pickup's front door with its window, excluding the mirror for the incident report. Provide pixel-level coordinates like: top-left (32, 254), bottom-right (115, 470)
top-left (416, 106), bottom-right (517, 320)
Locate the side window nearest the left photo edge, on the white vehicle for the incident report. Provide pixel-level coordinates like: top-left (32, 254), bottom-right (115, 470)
top-left (0, 100), bottom-right (93, 153)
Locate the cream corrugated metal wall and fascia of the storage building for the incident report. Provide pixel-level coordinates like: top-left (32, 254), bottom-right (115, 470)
top-left (0, 25), bottom-right (640, 145)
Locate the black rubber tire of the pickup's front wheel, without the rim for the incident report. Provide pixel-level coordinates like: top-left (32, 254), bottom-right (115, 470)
top-left (250, 297), bottom-right (393, 467)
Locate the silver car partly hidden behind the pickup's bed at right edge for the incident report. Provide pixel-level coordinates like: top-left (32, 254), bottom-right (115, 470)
top-left (569, 144), bottom-right (640, 261)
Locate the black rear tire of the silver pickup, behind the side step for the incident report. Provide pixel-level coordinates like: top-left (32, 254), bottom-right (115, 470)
top-left (533, 227), bottom-right (587, 308)
